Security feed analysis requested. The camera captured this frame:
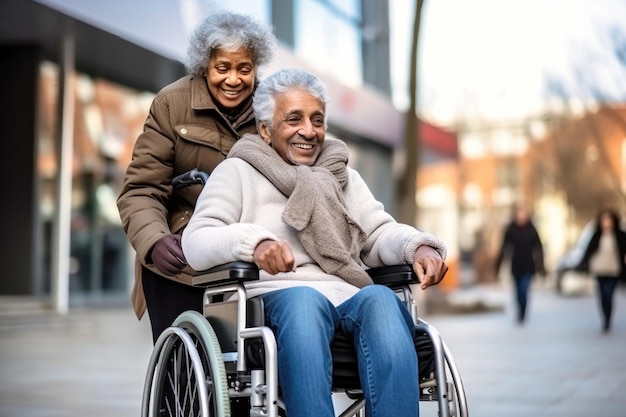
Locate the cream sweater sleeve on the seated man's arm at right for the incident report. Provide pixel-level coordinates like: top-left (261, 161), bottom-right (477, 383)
top-left (349, 170), bottom-right (447, 267)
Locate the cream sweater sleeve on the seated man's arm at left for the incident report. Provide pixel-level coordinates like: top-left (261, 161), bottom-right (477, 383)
top-left (182, 159), bottom-right (278, 271)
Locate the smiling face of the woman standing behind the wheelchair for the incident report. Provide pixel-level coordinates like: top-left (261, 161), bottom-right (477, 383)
top-left (207, 48), bottom-right (256, 110)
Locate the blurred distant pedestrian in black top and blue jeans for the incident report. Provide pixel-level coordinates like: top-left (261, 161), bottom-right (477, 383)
top-left (496, 206), bottom-right (545, 324)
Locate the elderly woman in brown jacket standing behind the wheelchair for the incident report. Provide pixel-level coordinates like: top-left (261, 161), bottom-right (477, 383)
top-left (118, 12), bottom-right (276, 340)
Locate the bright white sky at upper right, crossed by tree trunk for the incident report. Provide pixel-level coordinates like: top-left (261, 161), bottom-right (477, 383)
top-left (390, 0), bottom-right (626, 124)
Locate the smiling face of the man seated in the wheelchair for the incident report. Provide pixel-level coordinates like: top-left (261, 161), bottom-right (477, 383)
top-left (259, 88), bottom-right (326, 165)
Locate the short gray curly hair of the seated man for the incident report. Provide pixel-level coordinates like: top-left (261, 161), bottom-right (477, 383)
top-left (252, 68), bottom-right (329, 129)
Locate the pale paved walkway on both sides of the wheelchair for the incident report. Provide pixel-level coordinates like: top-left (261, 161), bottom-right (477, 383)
top-left (0, 287), bottom-right (626, 417)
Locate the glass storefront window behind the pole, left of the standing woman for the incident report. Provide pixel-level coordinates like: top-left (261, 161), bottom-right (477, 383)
top-left (37, 62), bottom-right (154, 298)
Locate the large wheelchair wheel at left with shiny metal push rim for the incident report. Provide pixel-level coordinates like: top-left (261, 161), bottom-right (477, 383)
top-left (142, 311), bottom-right (230, 417)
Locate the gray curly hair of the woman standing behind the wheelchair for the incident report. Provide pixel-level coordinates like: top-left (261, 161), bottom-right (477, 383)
top-left (185, 11), bottom-right (276, 75)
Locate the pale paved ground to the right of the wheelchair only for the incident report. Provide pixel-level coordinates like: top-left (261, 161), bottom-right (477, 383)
top-left (428, 282), bottom-right (626, 417)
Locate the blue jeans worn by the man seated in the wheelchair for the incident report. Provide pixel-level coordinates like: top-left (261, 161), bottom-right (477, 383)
top-left (262, 285), bottom-right (419, 417)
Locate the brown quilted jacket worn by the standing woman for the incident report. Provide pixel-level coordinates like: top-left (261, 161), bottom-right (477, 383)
top-left (117, 75), bottom-right (256, 318)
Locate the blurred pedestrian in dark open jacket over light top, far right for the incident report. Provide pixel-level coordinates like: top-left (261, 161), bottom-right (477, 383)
top-left (579, 209), bottom-right (626, 333)
